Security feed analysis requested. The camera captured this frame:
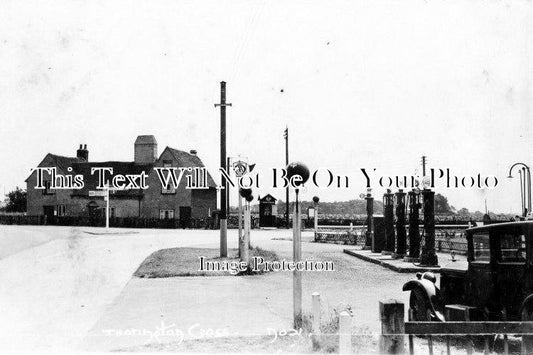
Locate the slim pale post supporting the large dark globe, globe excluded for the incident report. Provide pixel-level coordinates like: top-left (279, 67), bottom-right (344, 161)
top-left (292, 189), bottom-right (302, 329)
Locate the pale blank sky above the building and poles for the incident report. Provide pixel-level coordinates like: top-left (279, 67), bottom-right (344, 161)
top-left (0, 0), bottom-right (533, 213)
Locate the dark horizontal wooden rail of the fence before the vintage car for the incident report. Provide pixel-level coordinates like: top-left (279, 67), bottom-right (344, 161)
top-left (406, 322), bottom-right (533, 335)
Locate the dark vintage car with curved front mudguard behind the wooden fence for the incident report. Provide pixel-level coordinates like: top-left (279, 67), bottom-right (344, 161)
top-left (403, 221), bottom-right (533, 321)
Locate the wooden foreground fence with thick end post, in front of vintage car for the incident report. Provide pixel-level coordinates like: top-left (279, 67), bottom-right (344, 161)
top-left (379, 300), bottom-right (533, 355)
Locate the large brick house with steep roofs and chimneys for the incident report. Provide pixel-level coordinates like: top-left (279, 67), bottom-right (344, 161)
top-left (26, 135), bottom-right (217, 225)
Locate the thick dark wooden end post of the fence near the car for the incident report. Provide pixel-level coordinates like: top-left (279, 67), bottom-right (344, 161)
top-left (379, 300), bottom-right (405, 354)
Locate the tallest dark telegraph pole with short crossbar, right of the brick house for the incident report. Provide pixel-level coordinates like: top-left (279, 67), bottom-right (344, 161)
top-left (215, 81), bottom-right (231, 258)
